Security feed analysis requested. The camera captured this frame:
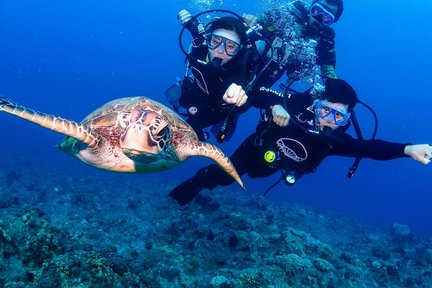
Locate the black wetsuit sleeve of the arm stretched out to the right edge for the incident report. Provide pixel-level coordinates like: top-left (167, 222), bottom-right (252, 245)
top-left (330, 134), bottom-right (410, 160)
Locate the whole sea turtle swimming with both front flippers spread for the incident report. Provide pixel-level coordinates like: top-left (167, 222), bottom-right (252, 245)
top-left (0, 96), bottom-right (243, 187)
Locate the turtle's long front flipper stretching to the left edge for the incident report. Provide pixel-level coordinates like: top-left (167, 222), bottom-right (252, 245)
top-left (0, 97), bottom-right (100, 148)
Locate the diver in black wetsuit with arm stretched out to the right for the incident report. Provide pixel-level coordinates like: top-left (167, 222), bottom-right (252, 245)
top-left (169, 78), bottom-right (432, 205)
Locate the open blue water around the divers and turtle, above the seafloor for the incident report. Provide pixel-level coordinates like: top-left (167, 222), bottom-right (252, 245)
top-left (0, 0), bottom-right (432, 236)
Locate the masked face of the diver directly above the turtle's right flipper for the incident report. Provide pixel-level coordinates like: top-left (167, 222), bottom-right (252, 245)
top-left (208, 28), bottom-right (240, 65)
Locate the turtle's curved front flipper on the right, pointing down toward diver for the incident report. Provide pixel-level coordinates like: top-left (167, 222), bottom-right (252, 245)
top-left (176, 140), bottom-right (245, 188)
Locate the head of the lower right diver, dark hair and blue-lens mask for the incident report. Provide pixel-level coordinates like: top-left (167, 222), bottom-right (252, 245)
top-left (314, 79), bottom-right (358, 131)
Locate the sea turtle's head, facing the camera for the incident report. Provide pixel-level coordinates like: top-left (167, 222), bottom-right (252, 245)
top-left (119, 109), bottom-right (170, 162)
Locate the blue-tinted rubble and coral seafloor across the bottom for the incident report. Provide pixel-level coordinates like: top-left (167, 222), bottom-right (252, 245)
top-left (0, 152), bottom-right (432, 288)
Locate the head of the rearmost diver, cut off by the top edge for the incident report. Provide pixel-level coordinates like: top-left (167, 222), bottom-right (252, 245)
top-left (309, 0), bottom-right (344, 28)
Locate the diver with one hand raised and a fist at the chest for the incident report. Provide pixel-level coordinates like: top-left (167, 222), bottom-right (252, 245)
top-left (165, 10), bottom-right (264, 142)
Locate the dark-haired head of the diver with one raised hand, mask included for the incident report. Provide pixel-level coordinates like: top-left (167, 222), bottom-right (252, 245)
top-left (206, 17), bottom-right (247, 65)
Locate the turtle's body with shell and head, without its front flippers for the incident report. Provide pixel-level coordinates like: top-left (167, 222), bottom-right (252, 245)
top-left (59, 96), bottom-right (198, 173)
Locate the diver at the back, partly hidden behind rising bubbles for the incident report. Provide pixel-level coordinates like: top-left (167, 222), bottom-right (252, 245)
top-left (243, 0), bottom-right (344, 87)
